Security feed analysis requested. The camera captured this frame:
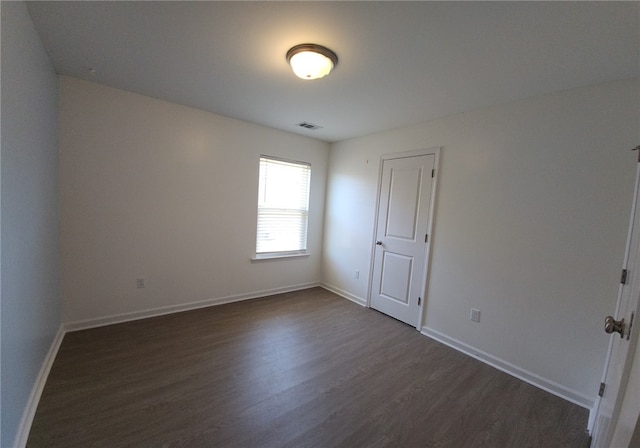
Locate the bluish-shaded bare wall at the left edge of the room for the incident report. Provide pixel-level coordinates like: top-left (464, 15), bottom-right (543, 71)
top-left (0, 2), bottom-right (61, 447)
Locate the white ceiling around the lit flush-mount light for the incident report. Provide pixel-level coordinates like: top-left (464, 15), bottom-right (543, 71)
top-left (29, 1), bottom-right (640, 142)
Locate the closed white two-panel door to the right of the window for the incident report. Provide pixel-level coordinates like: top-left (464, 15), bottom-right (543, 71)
top-left (370, 153), bottom-right (436, 329)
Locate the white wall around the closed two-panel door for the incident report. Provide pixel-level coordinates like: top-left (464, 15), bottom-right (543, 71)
top-left (323, 80), bottom-right (640, 406)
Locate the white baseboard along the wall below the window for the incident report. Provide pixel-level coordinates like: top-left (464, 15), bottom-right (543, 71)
top-left (65, 282), bottom-right (322, 331)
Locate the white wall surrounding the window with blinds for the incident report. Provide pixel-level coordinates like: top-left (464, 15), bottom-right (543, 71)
top-left (60, 77), bottom-right (329, 323)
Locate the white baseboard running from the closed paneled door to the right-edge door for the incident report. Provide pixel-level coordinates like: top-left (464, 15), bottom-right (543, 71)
top-left (421, 326), bottom-right (594, 411)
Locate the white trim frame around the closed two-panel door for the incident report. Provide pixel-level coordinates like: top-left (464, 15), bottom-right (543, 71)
top-left (367, 146), bottom-right (442, 331)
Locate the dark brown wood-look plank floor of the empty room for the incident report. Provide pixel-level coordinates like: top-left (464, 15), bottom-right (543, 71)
top-left (27, 288), bottom-right (588, 448)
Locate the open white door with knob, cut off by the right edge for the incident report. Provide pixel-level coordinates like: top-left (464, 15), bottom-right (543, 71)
top-left (591, 163), bottom-right (640, 448)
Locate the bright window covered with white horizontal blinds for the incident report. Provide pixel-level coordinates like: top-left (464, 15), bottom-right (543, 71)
top-left (256, 156), bottom-right (311, 258)
